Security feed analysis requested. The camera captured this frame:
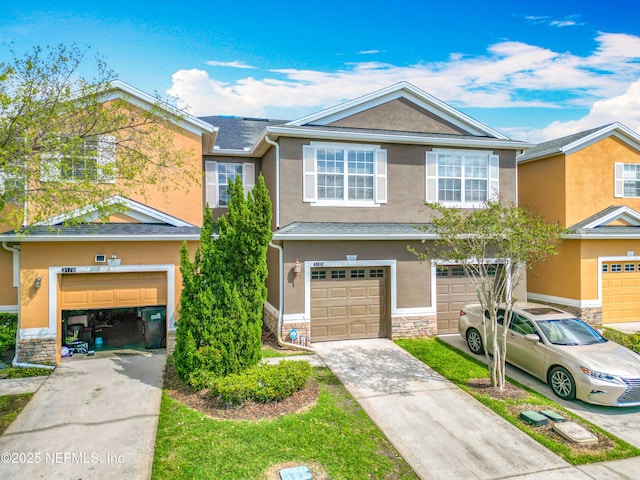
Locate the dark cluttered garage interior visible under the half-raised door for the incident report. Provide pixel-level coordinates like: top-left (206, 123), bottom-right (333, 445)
top-left (62, 305), bottom-right (166, 353)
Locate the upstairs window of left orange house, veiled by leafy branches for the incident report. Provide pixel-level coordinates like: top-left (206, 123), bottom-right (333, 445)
top-left (40, 135), bottom-right (116, 183)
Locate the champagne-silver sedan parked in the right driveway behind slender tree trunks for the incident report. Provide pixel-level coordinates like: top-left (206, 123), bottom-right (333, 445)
top-left (458, 303), bottom-right (640, 407)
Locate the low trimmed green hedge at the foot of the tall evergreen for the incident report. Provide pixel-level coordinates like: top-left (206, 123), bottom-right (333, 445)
top-left (208, 360), bottom-right (311, 407)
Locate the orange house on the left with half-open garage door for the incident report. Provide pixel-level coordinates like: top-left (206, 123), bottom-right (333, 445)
top-left (0, 82), bottom-right (217, 363)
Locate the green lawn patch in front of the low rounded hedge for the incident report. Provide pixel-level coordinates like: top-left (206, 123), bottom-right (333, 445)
top-left (152, 368), bottom-right (417, 480)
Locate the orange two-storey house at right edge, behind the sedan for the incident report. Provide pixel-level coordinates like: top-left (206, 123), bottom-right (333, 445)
top-left (518, 123), bottom-right (640, 324)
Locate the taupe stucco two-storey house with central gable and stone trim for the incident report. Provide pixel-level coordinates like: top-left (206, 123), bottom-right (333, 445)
top-left (204, 83), bottom-right (530, 343)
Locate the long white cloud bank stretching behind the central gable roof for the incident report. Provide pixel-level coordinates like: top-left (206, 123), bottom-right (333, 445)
top-left (168, 32), bottom-right (640, 140)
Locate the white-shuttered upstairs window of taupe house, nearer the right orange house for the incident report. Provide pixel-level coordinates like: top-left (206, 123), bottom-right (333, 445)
top-left (426, 149), bottom-right (500, 207)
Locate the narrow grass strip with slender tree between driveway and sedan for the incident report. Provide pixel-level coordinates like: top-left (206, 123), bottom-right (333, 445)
top-left (396, 338), bottom-right (640, 465)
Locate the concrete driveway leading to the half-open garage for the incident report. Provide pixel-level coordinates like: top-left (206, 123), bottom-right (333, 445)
top-left (0, 350), bottom-right (166, 480)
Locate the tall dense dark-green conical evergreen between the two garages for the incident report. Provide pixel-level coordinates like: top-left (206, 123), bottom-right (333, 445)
top-left (174, 176), bottom-right (272, 378)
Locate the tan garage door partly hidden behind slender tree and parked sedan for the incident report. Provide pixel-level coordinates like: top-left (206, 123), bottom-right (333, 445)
top-left (436, 265), bottom-right (478, 334)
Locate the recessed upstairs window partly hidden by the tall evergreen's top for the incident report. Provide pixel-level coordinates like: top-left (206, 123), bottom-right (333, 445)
top-left (205, 161), bottom-right (255, 208)
